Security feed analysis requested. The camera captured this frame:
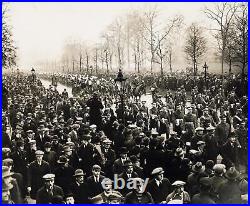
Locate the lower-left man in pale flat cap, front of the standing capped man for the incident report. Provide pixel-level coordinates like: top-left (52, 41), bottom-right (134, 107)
top-left (36, 173), bottom-right (64, 204)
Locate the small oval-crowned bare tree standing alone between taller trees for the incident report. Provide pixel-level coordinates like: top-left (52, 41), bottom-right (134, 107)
top-left (184, 23), bottom-right (207, 75)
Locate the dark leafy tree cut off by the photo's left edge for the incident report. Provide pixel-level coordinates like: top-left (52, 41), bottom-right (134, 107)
top-left (2, 4), bottom-right (17, 68)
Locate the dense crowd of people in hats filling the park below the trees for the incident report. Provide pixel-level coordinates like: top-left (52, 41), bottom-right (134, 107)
top-left (2, 73), bottom-right (248, 204)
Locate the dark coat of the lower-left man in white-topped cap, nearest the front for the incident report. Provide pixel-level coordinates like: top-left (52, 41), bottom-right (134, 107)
top-left (36, 185), bottom-right (64, 204)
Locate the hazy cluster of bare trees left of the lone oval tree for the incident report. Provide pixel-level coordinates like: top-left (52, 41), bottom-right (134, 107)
top-left (53, 8), bottom-right (183, 74)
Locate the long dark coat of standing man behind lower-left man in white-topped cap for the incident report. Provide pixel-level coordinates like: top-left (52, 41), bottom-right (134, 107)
top-left (28, 161), bottom-right (50, 198)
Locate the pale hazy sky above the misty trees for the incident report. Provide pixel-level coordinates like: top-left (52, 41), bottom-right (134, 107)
top-left (8, 2), bottom-right (219, 69)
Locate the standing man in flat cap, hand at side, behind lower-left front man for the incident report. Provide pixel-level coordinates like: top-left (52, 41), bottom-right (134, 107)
top-left (27, 150), bottom-right (50, 199)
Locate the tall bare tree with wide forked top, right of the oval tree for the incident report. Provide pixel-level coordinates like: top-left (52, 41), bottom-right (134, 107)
top-left (204, 3), bottom-right (237, 76)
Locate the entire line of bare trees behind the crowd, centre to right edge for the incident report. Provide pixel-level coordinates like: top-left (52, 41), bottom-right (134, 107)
top-left (54, 3), bottom-right (248, 75)
